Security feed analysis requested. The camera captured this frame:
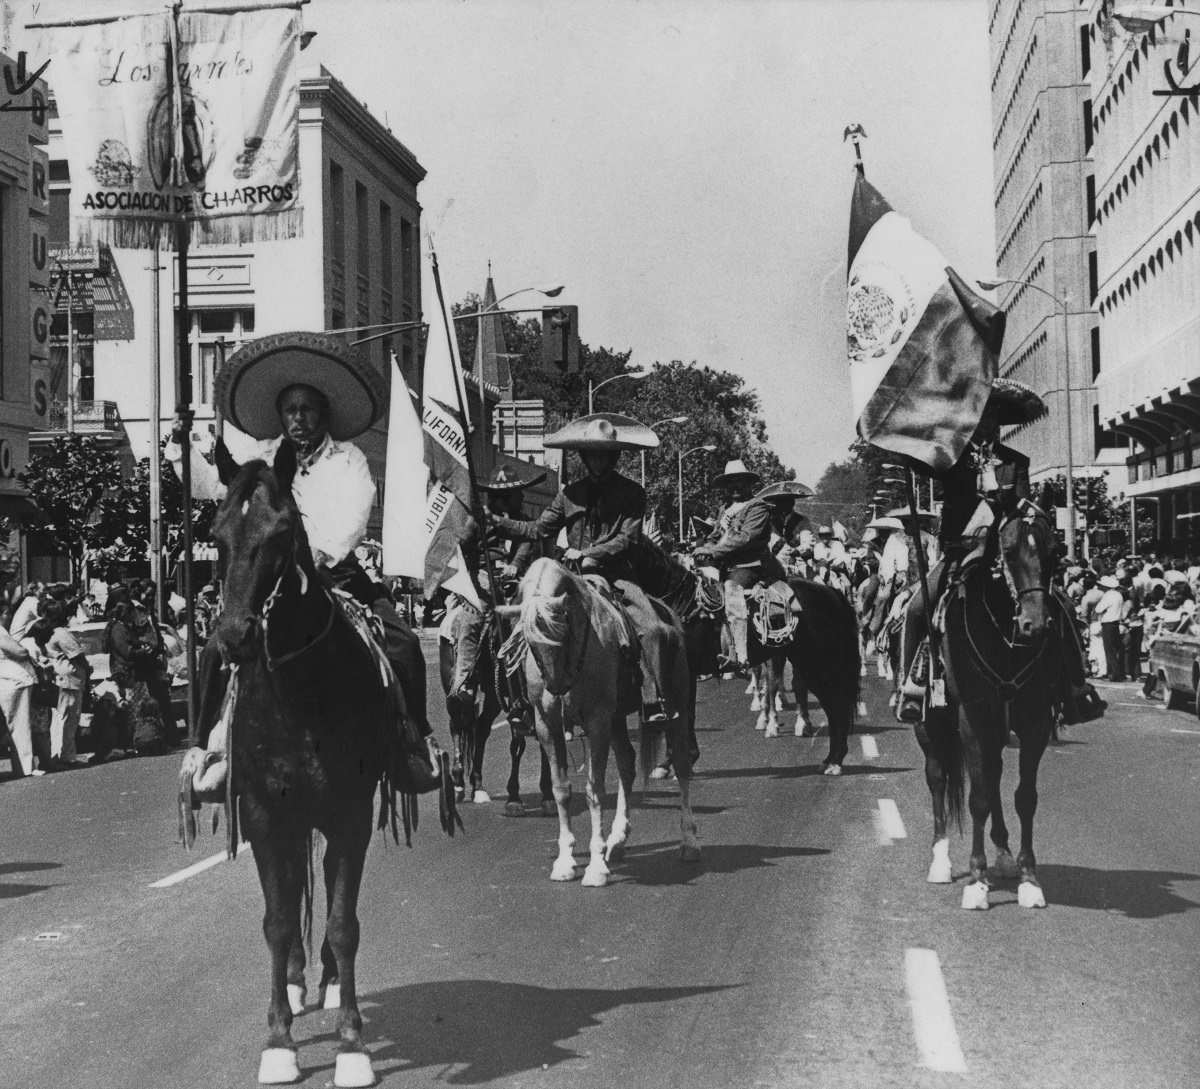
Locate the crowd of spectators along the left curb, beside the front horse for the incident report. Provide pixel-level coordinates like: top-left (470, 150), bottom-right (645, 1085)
top-left (0, 579), bottom-right (184, 777)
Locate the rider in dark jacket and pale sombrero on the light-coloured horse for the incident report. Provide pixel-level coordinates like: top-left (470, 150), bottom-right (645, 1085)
top-left (493, 413), bottom-right (665, 721)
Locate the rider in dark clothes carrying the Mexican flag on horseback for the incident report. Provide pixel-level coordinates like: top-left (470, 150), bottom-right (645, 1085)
top-left (896, 378), bottom-right (1105, 723)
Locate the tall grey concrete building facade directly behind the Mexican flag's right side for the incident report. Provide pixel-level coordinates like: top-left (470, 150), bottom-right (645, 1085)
top-left (989, 0), bottom-right (1124, 494)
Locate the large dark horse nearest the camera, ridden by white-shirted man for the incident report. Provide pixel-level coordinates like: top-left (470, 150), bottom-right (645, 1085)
top-left (212, 443), bottom-right (408, 1085)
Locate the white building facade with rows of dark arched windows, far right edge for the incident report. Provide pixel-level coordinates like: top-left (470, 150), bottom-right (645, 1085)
top-left (1081, 0), bottom-right (1200, 556)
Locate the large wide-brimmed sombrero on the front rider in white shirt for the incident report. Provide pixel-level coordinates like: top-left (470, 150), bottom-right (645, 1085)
top-left (216, 332), bottom-right (388, 439)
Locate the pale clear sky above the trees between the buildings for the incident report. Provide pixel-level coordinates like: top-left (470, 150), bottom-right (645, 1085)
top-left (11, 0), bottom-right (995, 483)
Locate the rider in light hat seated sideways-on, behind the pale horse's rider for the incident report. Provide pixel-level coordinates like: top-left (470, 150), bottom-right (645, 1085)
top-left (695, 458), bottom-right (796, 667)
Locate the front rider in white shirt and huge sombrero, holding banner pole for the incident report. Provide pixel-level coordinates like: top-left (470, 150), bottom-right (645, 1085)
top-left (180, 332), bottom-right (431, 746)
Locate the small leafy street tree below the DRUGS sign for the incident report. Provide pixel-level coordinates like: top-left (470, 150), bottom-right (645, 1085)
top-left (20, 434), bottom-right (121, 578)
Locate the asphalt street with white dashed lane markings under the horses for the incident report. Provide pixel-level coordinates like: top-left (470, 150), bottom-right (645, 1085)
top-left (0, 638), bottom-right (1200, 1089)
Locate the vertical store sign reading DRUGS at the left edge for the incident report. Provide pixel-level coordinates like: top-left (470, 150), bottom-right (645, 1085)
top-left (27, 82), bottom-right (50, 426)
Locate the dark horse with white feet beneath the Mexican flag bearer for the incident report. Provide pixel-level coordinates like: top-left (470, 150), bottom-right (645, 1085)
top-left (917, 501), bottom-right (1062, 910)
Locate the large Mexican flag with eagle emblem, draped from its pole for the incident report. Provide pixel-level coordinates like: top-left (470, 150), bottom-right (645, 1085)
top-left (846, 172), bottom-right (1004, 473)
